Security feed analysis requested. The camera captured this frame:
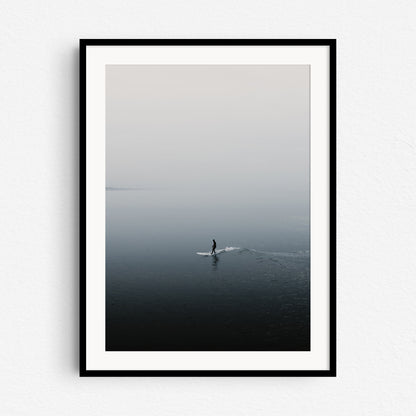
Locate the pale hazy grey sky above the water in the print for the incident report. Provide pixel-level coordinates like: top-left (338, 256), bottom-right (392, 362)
top-left (106, 65), bottom-right (309, 202)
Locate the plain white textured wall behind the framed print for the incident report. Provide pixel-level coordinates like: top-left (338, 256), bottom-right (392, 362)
top-left (0, 0), bottom-right (416, 416)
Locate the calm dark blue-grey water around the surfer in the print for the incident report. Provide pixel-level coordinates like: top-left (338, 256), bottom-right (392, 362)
top-left (106, 189), bottom-right (310, 351)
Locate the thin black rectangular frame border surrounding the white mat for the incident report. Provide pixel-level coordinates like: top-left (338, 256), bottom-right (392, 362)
top-left (79, 39), bottom-right (336, 377)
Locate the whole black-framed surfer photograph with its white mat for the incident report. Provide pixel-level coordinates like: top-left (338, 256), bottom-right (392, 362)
top-left (80, 39), bottom-right (336, 376)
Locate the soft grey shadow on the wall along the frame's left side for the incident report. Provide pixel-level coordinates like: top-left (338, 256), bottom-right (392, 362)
top-left (53, 47), bottom-right (80, 374)
